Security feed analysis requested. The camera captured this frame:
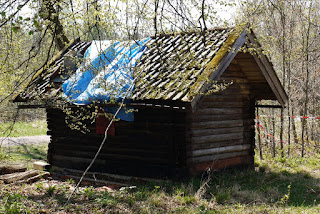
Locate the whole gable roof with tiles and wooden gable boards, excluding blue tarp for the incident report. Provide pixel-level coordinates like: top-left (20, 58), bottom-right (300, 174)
top-left (15, 28), bottom-right (288, 109)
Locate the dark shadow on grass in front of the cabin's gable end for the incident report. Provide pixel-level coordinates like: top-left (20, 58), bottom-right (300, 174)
top-left (200, 167), bottom-right (320, 207)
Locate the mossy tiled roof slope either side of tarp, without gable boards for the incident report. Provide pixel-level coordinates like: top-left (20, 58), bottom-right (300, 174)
top-left (15, 28), bottom-right (250, 105)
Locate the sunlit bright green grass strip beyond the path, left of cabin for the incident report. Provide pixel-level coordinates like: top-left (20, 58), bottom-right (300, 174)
top-left (0, 120), bottom-right (47, 137)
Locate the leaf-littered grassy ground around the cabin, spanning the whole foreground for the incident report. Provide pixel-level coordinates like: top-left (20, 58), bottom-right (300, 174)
top-left (0, 141), bottom-right (320, 213)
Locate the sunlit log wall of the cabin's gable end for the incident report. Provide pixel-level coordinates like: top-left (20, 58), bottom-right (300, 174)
top-left (186, 65), bottom-right (255, 174)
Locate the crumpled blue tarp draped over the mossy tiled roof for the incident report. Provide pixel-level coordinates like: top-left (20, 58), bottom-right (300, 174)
top-left (62, 38), bottom-right (150, 121)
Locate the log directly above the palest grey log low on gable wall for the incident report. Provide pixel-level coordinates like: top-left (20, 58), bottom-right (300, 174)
top-left (191, 132), bottom-right (251, 144)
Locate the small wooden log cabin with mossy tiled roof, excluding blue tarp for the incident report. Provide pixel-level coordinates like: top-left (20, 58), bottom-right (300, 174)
top-left (14, 28), bottom-right (288, 177)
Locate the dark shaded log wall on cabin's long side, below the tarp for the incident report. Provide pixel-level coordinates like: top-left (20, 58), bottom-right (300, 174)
top-left (47, 109), bottom-right (186, 177)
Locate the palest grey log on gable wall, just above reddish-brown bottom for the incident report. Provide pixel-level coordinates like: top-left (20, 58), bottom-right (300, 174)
top-left (192, 144), bottom-right (251, 157)
